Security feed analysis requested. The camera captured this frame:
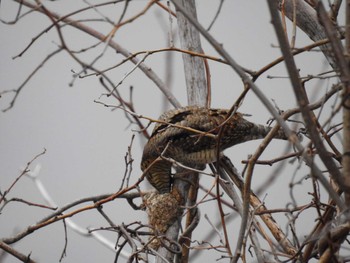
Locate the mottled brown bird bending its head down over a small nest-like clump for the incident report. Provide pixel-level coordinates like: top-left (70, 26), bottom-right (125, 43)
top-left (141, 106), bottom-right (288, 194)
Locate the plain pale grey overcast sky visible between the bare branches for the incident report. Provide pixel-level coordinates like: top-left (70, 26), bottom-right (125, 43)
top-left (0, 0), bottom-right (340, 262)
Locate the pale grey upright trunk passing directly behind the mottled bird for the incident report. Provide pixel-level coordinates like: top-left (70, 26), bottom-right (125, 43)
top-left (157, 0), bottom-right (207, 263)
